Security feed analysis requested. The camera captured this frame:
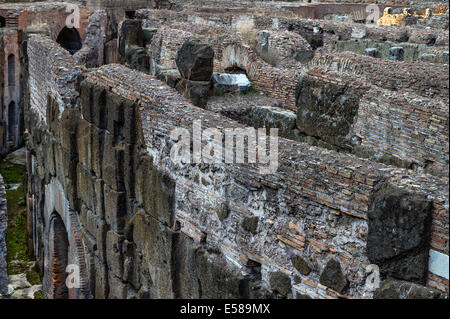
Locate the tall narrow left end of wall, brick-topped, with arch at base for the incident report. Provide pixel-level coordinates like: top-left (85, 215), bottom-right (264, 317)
top-left (25, 35), bottom-right (89, 298)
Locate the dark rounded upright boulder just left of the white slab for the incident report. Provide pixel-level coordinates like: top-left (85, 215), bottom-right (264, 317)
top-left (175, 41), bottom-right (214, 82)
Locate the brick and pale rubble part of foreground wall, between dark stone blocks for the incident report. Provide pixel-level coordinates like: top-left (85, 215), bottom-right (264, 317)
top-left (82, 66), bottom-right (448, 297)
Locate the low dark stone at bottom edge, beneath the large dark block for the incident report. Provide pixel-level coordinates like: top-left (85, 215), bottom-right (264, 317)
top-left (374, 278), bottom-right (443, 299)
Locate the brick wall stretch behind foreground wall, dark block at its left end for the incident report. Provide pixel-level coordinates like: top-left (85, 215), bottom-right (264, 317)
top-left (297, 65), bottom-right (448, 175)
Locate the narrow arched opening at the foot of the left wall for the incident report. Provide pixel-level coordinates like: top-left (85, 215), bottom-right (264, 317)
top-left (50, 213), bottom-right (69, 299)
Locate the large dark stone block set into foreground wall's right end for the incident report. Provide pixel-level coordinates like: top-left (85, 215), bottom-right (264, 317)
top-left (367, 185), bottom-right (432, 284)
